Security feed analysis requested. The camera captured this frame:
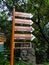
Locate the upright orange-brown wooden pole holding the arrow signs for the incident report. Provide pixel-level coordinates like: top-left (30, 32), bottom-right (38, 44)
top-left (10, 7), bottom-right (15, 65)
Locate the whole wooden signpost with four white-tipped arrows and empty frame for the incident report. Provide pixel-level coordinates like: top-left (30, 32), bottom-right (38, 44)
top-left (10, 8), bottom-right (35, 65)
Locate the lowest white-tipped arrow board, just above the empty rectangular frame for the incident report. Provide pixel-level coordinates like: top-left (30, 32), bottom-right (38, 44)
top-left (14, 34), bottom-right (35, 41)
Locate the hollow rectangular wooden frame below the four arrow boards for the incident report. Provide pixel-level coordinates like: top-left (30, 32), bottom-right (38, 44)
top-left (15, 42), bottom-right (32, 49)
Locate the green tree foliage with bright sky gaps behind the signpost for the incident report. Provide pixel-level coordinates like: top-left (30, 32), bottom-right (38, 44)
top-left (0, 0), bottom-right (49, 63)
